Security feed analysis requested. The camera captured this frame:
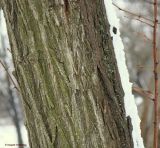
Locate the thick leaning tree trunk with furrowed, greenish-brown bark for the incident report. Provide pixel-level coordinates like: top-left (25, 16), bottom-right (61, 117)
top-left (2, 0), bottom-right (133, 148)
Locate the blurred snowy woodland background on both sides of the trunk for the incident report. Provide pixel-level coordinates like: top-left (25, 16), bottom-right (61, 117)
top-left (0, 0), bottom-right (160, 148)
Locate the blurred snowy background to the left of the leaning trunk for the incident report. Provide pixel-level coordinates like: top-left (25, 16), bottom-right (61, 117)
top-left (0, 10), bottom-right (28, 148)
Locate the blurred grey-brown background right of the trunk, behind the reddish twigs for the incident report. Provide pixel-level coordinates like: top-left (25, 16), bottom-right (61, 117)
top-left (114, 0), bottom-right (160, 148)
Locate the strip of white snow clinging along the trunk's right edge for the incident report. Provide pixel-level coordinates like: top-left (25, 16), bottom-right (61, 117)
top-left (104, 0), bottom-right (144, 148)
